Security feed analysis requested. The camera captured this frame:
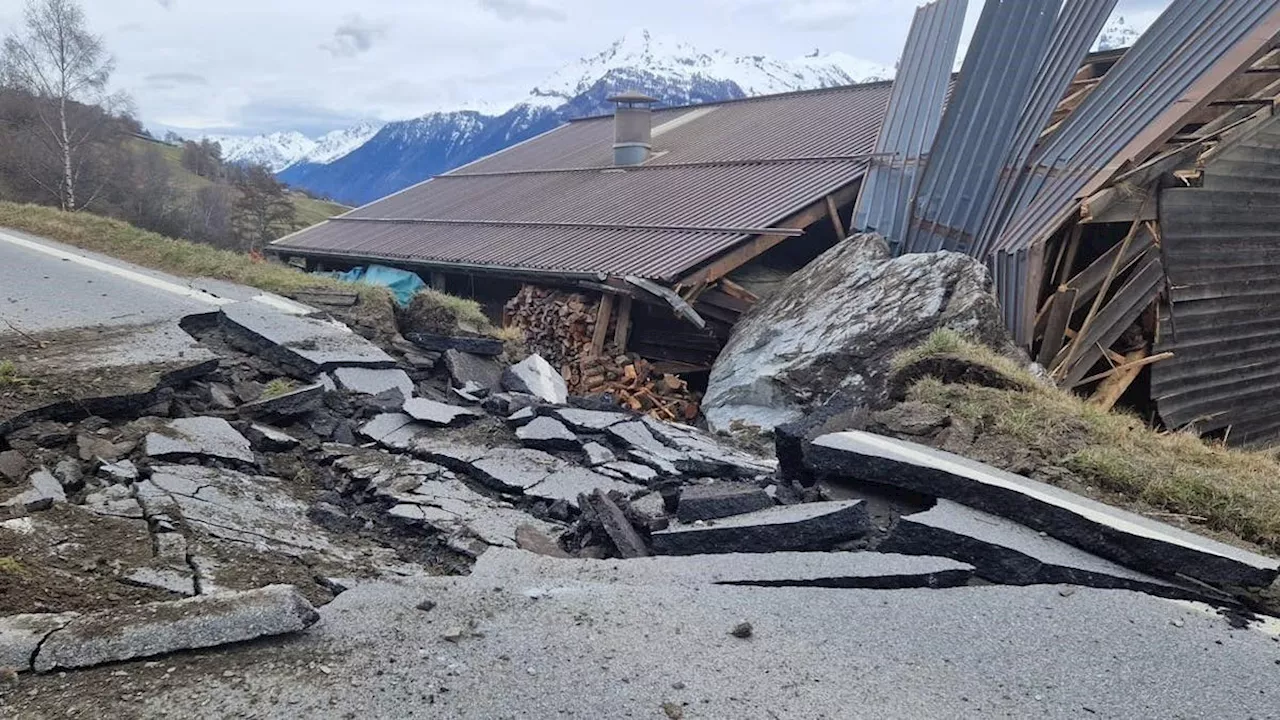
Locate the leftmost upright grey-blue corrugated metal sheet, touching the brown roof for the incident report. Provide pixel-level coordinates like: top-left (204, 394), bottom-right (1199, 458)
top-left (852, 0), bottom-right (968, 245)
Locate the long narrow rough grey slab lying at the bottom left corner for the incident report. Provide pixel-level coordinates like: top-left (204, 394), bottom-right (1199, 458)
top-left (33, 585), bottom-right (320, 673)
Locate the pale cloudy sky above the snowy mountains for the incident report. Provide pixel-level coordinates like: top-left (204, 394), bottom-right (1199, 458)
top-left (0, 0), bottom-right (1167, 136)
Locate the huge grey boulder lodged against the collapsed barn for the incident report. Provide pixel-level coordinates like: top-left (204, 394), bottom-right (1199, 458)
top-left (701, 234), bottom-right (1009, 432)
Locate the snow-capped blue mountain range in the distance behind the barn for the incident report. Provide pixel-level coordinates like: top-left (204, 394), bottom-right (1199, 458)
top-left (212, 18), bottom-right (1139, 205)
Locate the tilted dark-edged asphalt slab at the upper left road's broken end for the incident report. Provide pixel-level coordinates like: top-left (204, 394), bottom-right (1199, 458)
top-left (219, 302), bottom-right (396, 377)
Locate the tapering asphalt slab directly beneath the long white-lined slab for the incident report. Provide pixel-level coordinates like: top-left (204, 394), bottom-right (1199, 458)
top-left (877, 500), bottom-right (1204, 600)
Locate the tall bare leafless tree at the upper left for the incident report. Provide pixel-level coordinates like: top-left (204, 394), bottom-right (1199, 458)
top-left (0, 0), bottom-right (115, 210)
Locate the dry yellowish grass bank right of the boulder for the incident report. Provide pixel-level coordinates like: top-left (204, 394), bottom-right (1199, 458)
top-left (909, 330), bottom-right (1280, 552)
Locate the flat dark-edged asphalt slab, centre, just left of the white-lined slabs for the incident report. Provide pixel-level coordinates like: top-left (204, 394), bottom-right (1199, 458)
top-left (649, 500), bottom-right (870, 555)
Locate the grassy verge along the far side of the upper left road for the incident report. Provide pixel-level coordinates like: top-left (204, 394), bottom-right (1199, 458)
top-left (0, 201), bottom-right (371, 295)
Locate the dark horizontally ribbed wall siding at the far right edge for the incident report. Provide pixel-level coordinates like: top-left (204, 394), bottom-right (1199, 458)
top-left (1151, 120), bottom-right (1280, 446)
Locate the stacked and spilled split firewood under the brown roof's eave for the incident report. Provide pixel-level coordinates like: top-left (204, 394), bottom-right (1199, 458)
top-left (504, 284), bottom-right (699, 421)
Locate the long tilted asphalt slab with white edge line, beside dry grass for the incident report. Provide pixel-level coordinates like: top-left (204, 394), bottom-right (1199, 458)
top-left (804, 430), bottom-right (1280, 587)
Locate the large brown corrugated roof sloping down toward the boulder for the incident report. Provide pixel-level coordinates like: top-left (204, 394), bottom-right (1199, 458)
top-left (275, 83), bottom-right (891, 281)
